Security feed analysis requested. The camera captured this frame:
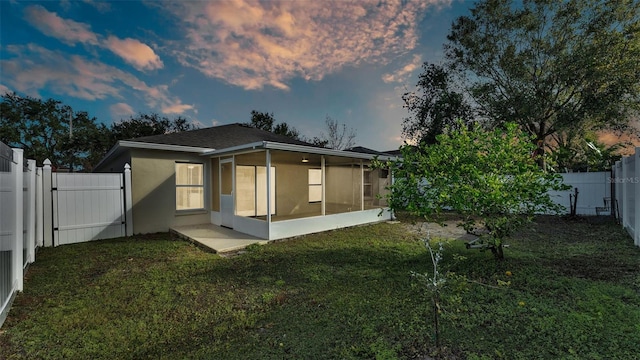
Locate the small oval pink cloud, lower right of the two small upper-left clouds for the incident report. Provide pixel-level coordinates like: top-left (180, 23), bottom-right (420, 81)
top-left (104, 36), bottom-right (163, 70)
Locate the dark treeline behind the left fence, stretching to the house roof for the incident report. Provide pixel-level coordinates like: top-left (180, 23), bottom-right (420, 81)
top-left (0, 93), bottom-right (196, 172)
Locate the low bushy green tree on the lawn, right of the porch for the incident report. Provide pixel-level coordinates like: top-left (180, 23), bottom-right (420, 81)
top-left (378, 123), bottom-right (564, 259)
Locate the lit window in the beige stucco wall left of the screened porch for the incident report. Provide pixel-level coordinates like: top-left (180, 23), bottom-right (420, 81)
top-left (176, 163), bottom-right (204, 210)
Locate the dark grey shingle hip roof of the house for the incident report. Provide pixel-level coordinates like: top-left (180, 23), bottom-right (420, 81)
top-left (130, 123), bottom-right (313, 150)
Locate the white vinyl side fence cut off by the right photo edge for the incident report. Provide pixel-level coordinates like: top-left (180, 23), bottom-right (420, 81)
top-left (611, 147), bottom-right (640, 246)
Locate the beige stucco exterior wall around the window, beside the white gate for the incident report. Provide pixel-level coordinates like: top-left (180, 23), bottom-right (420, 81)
top-left (131, 149), bottom-right (211, 234)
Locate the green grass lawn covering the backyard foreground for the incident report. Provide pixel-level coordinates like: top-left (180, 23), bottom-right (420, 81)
top-left (0, 217), bottom-right (640, 359)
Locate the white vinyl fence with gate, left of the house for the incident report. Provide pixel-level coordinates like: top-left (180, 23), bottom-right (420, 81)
top-left (0, 142), bottom-right (133, 326)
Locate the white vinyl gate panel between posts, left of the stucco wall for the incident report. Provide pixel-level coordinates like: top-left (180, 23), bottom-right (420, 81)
top-left (52, 173), bottom-right (126, 246)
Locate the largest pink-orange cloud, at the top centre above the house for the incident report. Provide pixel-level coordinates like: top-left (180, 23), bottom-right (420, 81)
top-left (158, 0), bottom-right (450, 90)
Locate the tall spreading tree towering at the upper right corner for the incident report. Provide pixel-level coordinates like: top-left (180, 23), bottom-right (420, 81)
top-left (445, 0), bottom-right (640, 157)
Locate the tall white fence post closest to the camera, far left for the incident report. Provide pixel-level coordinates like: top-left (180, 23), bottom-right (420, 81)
top-left (12, 149), bottom-right (24, 291)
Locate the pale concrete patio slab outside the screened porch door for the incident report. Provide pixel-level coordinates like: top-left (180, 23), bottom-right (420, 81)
top-left (169, 224), bottom-right (268, 254)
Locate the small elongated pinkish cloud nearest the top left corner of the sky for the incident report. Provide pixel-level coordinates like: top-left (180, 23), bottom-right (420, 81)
top-left (24, 5), bottom-right (98, 45)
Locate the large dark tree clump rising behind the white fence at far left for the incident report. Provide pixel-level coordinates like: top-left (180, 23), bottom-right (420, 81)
top-left (0, 93), bottom-right (109, 171)
